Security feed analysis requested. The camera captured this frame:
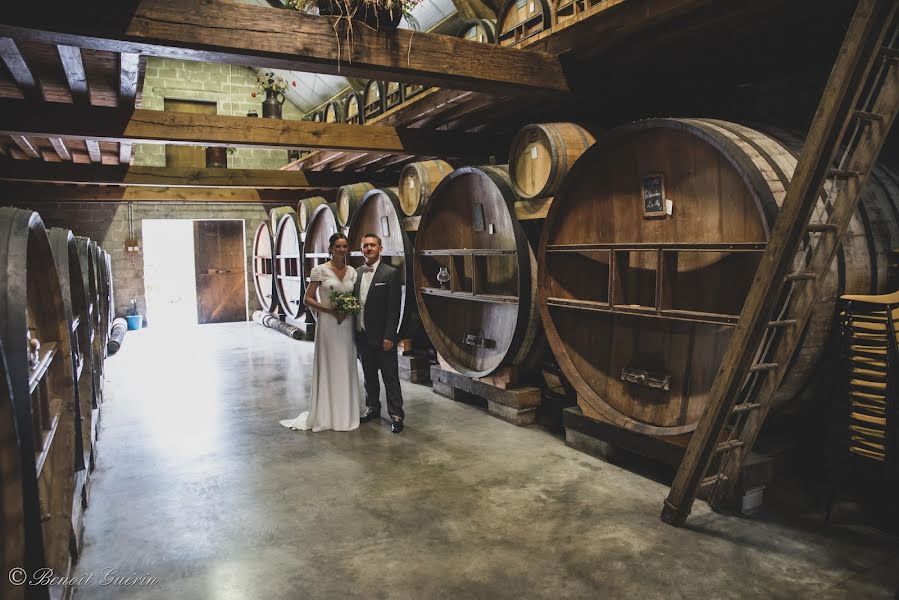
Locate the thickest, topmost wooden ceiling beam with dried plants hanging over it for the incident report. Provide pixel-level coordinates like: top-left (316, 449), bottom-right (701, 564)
top-left (0, 0), bottom-right (569, 93)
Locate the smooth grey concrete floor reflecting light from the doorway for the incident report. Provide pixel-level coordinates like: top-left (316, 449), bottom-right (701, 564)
top-left (74, 323), bottom-right (899, 600)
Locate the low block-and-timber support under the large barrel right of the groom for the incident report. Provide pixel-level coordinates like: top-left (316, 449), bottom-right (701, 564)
top-left (431, 365), bottom-right (541, 426)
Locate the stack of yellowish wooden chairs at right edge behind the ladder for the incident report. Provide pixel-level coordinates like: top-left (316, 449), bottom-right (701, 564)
top-left (827, 292), bottom-right (899, 525)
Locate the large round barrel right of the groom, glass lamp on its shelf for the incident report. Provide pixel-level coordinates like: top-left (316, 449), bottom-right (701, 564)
top-left (415, 167), bottom-right (539, 377)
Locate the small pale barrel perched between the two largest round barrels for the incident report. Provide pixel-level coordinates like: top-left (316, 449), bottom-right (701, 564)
top-left (509, 123), bottom-right (596, 200)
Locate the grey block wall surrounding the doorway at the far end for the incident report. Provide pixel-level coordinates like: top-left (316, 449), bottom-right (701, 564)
top-left (20, 202), bottom-right (284, 324)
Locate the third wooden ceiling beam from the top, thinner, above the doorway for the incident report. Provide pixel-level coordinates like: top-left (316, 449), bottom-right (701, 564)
top-left (0, 160), bottom-right (383, 190)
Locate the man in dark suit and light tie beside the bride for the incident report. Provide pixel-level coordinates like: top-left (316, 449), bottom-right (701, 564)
top-left (353, 233), bottom-right (405, 433)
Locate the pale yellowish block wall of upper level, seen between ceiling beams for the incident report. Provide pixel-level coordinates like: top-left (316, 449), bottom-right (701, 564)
top-left (133, 57), bottom-right (303, 169)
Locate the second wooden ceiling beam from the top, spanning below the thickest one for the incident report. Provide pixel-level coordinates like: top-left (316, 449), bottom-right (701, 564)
top-left (0, 99), bottom-right (500, 158)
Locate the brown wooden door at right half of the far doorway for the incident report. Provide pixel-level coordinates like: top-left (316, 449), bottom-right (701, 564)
top-left (194, 220), bottom-right (247, 325)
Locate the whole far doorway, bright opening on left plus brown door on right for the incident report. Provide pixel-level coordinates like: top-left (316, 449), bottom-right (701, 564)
top-left (142, 219), bottom-right (247, 328)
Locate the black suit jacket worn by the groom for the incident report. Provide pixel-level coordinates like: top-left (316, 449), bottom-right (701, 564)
top-left (353, 259), bottom-right (402, 346)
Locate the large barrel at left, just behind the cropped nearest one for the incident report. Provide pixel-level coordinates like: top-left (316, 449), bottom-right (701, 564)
top-left (0, 208), bottom-right (75, 596)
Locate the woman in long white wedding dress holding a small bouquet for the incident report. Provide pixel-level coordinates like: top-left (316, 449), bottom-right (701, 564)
top-left (281, 233), bottom-right (359, 431)
